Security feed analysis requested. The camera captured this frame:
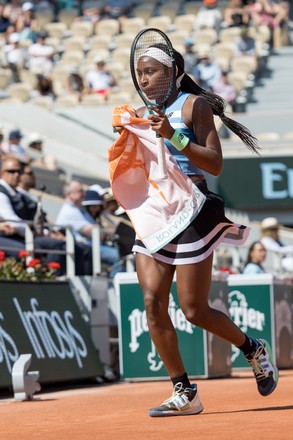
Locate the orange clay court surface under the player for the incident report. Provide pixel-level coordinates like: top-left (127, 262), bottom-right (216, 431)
top-left (0, 370), bottom-right (293, 440)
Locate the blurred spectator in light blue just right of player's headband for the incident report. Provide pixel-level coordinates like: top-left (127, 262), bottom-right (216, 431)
top-left (192, 51), bottom-right (222, 91)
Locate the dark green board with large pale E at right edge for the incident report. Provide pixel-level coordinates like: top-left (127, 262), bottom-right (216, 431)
top-left (217, 156), bottom-right (293, 211)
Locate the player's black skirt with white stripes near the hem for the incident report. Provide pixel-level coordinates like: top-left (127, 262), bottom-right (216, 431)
top-left (132, 180), bottom-right (250, 265)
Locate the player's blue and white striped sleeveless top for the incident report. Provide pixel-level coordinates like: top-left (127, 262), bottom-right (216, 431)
top-left (144, 92), bottom-right (204, 176)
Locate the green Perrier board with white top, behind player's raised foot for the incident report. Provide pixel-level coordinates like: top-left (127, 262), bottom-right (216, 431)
top-left (228, 274), bottom-right (276, 369)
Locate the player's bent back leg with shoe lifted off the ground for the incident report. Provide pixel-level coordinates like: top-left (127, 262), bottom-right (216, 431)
top-left (176, 255), bottom-right (278, 396)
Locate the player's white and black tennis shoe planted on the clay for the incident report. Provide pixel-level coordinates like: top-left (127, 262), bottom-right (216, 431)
top-left (149, 382), bottom-right (203, 417)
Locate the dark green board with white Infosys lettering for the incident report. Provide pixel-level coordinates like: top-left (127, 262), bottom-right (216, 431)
top-left (0, 281), bottom-right (103, 387)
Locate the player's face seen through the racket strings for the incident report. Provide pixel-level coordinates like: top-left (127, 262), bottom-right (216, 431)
top-left (137, 56), bottom-right (171, 103)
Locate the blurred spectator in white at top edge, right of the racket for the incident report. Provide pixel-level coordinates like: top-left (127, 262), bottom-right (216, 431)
top-left (195, 0), bottom-right (222, 33)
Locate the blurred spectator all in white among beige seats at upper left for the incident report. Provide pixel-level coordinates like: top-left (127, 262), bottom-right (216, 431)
top-left (27, 32), bottom-right (55, 77)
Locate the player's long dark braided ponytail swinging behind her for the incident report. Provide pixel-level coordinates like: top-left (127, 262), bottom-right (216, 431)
top-left (173, 49), bottom-right (260, 155)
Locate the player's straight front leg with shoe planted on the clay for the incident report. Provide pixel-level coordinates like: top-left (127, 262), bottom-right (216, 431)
top-left (136, 254), bottom-right (203, 417)
